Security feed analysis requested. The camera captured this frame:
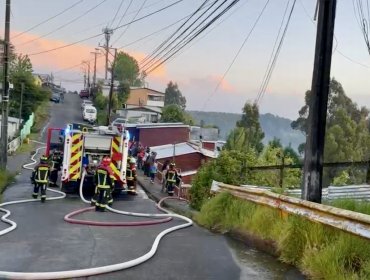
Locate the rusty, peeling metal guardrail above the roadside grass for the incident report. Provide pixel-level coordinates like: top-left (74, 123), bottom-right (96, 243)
top-left (211, 182), bottom-right (370, 239)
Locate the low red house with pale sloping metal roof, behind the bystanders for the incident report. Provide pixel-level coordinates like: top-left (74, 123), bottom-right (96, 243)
top-left (151, 142), bottom-right (216, 184)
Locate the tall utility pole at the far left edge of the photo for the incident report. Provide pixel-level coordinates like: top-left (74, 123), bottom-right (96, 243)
top-left (0, 0), bottom-right (10, 170)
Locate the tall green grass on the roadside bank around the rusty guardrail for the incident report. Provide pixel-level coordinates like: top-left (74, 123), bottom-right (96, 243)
top-left (196, 193), bottom-right (370, 280)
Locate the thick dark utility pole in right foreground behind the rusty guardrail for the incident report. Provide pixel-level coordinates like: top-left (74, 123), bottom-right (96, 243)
top-left (302, 0), bottom-right (337, 203)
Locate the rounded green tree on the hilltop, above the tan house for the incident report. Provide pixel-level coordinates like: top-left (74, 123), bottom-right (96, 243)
top-left (114, 52), bottom-right (142, 86)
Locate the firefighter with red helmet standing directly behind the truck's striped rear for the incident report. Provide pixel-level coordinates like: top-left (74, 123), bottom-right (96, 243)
top-left (91, 156), bottom-right (114, 212)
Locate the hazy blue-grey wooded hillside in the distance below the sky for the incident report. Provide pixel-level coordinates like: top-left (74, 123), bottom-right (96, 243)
top-left (187, 111), bottom-right (305, 150)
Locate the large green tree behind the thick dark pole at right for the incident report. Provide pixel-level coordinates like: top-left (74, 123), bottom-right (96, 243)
top-left (291, 78), bottom-right (370, 185)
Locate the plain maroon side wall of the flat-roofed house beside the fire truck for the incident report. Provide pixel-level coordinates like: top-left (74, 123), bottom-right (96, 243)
top-left (139, 127), bottom-right (189, 147)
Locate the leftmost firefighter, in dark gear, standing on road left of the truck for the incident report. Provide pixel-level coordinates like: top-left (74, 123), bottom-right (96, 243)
top-left (31, 156), bottom-right (50, 202)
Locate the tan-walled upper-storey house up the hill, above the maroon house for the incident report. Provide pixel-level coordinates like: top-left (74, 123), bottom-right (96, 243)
top-left (117, 87), bottom-right (164, 123)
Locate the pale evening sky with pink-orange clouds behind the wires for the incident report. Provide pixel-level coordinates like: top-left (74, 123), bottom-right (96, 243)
top-left (0, 0), bottom-right (370, 119)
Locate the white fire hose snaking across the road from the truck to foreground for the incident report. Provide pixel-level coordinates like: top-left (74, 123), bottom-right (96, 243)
top-left (0, 143), bottom-right (193, 280)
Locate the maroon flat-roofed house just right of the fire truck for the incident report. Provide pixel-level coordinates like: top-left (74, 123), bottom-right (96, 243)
top-left (125, 123), bottom-right (190, 147)
